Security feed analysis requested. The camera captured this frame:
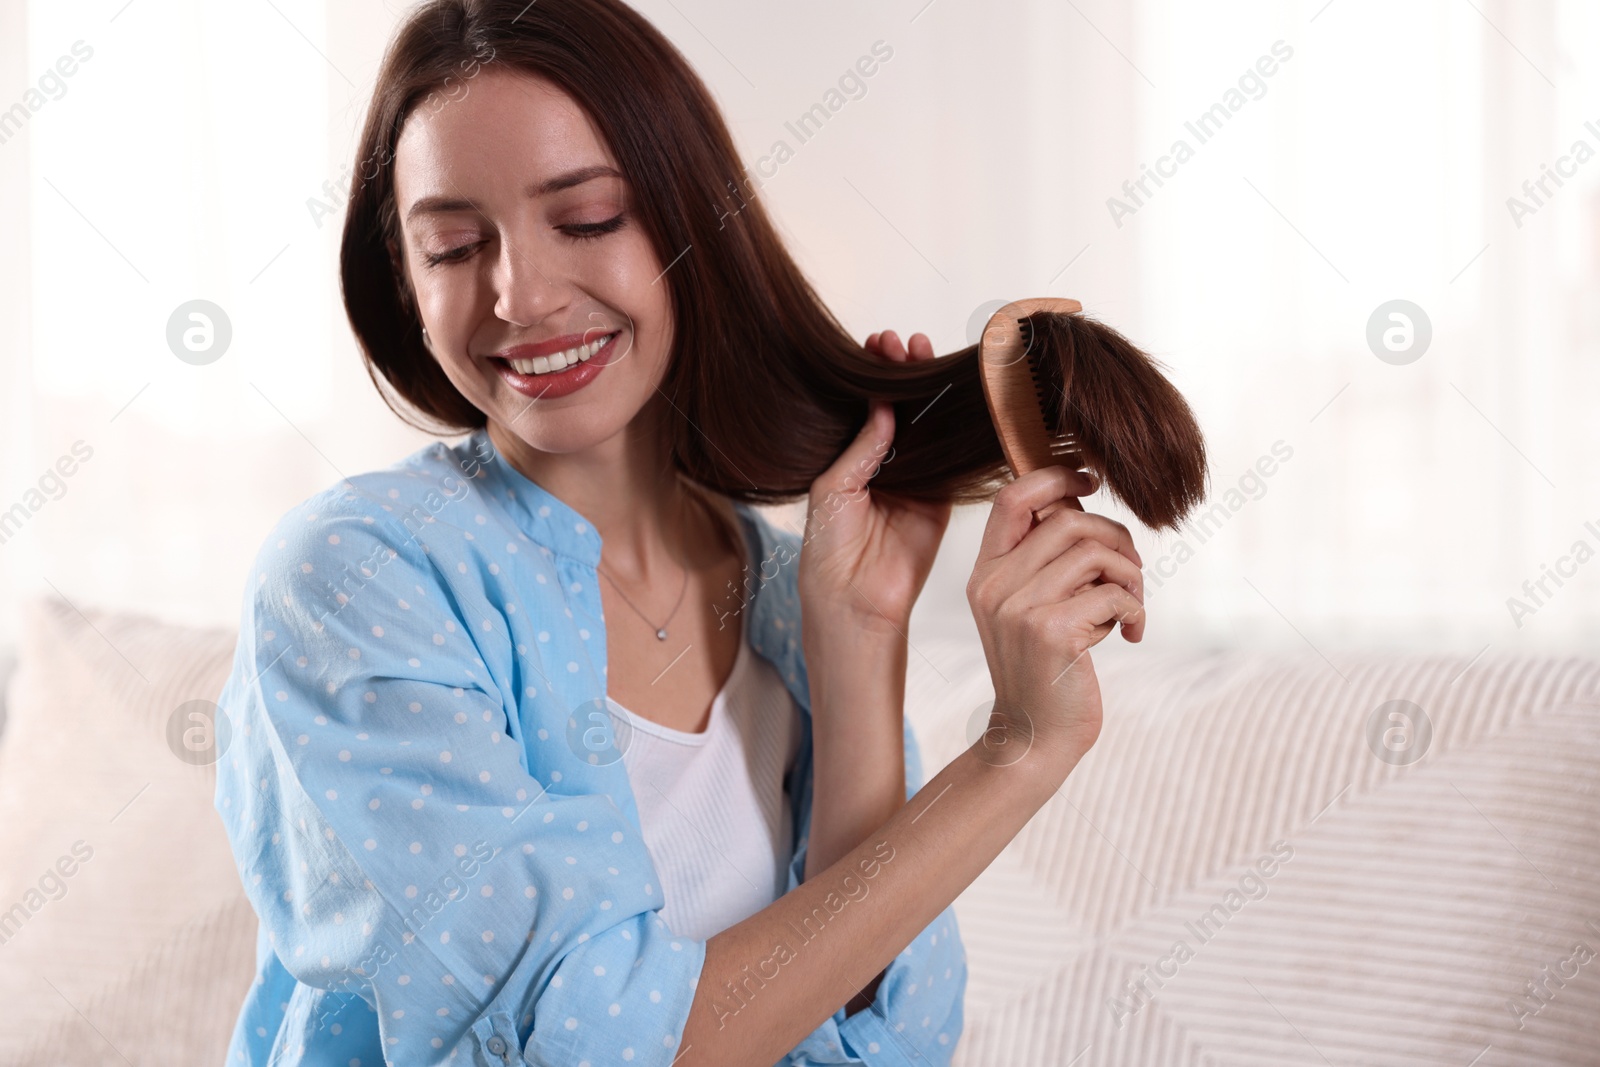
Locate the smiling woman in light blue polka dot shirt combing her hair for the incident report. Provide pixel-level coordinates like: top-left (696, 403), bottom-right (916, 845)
top-left (216, 0), bottom-right (1190, 1067)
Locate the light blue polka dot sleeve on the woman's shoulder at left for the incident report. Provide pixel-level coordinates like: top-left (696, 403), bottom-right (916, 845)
top-left (216, 498), bottom-right (707, 1067)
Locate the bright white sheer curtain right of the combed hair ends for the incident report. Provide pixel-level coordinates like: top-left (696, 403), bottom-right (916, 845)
top-left (1100, 0), bottom-right (1600, 657)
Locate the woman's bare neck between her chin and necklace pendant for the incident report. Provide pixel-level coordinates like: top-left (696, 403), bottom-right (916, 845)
top-left (488, 408), bottom-right (728, 585)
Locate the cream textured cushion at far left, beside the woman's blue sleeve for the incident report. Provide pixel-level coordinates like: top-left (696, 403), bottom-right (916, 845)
top-left (0, 598), bottom-right (256, 1065)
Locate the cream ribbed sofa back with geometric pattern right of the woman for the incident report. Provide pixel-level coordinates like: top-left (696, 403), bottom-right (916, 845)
top-left (907, 637), bottom-right (1600, 1067)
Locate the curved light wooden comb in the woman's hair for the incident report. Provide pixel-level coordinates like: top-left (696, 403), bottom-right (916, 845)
top-left (979, 296), bottom-right (1083, 522)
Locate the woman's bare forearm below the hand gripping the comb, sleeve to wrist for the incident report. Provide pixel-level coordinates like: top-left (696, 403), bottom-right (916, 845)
top-left (678, 741), bottom-right (1080, 1067)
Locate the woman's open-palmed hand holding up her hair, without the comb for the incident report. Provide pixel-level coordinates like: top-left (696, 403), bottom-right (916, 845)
top-left (798, 330), bottom-right (950, 638)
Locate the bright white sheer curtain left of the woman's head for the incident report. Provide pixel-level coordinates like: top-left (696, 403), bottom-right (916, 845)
top-left (0, 0), bottom-right (424, 640)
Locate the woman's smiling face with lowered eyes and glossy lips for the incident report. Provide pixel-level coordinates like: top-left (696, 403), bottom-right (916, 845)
top-left (395, 67), bottom-right (672, 453)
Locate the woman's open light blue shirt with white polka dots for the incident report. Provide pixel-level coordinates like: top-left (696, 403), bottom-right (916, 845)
top-left (216, 430), bottom-right (966, 1067)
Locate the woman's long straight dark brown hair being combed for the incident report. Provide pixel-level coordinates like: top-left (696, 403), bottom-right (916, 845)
top-left (339, 0), bottom-right (1205, 528)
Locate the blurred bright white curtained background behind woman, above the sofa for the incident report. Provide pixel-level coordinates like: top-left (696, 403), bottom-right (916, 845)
top-left (0, 0), bottom-right (1600, 657)
